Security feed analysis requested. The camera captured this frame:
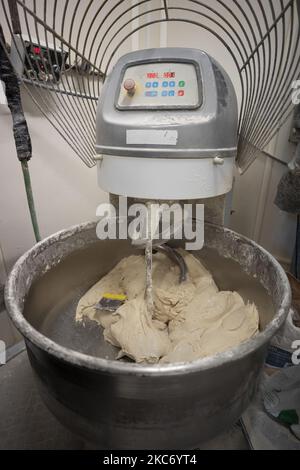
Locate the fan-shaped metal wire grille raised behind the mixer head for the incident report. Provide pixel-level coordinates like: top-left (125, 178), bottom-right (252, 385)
top-left (0, 0), bottom-right (300, 171)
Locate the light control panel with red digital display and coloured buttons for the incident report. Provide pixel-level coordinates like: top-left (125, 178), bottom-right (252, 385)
top-left (117, 62), bottom-right (202, 109)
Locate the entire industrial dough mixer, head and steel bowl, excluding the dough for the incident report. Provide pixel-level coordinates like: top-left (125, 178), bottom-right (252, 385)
top-left (6, 48), bottom-right (290, 448)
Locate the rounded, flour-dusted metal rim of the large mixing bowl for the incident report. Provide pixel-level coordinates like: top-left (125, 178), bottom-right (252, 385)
top-left (5, 222), bottom-right (291, 376)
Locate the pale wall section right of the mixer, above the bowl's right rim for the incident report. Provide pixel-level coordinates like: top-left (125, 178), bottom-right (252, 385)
top-left (230, 116), bottom-right (296, 268)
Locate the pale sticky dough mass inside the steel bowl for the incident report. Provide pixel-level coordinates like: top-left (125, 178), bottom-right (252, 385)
top-left (76, 250), bottom-right (259, 363)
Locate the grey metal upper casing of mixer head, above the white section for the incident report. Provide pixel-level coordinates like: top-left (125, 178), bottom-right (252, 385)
top-left (96, 47), bottom-right (238, 159)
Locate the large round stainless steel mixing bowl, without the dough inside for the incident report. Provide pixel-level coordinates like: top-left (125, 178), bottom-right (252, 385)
top-left (6, 223), bottom-right (290, 449)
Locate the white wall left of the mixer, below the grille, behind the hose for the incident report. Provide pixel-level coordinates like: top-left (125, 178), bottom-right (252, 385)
top-left (0, 95), bottom-right (106, 269)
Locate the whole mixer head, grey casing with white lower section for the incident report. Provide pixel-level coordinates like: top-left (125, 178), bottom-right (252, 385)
top-left (96, 48), bottom-right (238, 200)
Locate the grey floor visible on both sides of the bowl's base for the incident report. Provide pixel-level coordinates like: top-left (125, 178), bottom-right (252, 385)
top-left (0, 352), bottom-right (249, 450)
